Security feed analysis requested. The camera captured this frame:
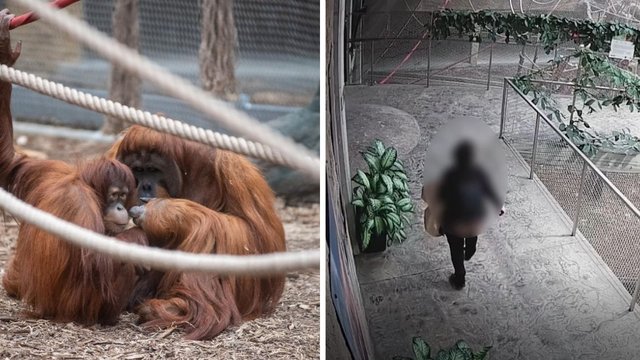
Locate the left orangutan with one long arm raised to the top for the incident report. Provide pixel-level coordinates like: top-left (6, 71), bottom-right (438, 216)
top-left (0, 10), bottom-right (146, 325)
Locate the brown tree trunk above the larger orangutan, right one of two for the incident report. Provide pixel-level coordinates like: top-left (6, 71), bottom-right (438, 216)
top-left (199, 0), bottom-right (236, 100)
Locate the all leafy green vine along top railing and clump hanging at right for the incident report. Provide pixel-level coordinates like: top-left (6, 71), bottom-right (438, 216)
top-left (431, 9), bottom-right (640, 156)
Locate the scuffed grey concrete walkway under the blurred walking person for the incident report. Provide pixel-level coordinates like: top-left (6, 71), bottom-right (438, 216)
top-left (347, 86), bottom-right (640, 359)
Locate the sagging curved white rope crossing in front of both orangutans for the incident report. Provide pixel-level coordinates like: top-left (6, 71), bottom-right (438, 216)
top-left (0, 188), bottom-right (320, 276)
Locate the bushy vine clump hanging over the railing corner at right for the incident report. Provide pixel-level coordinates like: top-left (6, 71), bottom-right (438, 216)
top-left (513, 49), bottom-right (640, 156)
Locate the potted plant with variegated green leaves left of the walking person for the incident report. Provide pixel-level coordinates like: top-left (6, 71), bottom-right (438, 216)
top-left (351, 139), bottom-right (413, 252)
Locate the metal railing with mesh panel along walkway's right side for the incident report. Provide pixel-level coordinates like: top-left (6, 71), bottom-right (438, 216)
top-left (499, 79), bottom-right (640, 311)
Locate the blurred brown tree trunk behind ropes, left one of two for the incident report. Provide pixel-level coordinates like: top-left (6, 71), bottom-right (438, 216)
top-left (102, 0), bottom-right (142, 134)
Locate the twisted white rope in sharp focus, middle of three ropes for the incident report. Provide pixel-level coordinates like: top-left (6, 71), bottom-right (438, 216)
top-left (0, 65), bottom-right (293, 166)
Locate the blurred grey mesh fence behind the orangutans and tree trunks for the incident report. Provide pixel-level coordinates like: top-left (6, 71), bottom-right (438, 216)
top-left (0, 0), bottom-right (320, 128)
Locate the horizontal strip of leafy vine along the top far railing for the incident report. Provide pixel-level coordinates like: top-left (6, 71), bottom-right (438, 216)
top-left (432, 9), bottom-right (640, 53)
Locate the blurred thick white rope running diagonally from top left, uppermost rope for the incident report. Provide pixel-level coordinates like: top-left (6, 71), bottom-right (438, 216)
top-left (17, 0), bottom-right (321, 182)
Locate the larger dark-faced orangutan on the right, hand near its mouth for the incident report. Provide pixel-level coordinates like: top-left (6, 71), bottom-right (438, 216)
top-left (111, 126), bottom-right (286, 339)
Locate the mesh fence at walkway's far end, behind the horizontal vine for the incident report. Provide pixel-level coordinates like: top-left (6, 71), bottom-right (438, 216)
top-left (348, 0), bottom-right (640, 86)
